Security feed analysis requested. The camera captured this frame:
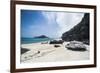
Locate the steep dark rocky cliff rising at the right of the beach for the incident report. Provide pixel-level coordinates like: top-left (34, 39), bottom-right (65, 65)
top-left (62, 13), bottom-right (89, 44)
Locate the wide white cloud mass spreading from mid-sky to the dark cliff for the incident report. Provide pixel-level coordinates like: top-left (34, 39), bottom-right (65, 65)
top-left (42, 11), bottom-right (84, 37)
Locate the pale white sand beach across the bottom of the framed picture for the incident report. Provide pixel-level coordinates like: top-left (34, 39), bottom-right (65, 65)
top-left (21, 42), bottom-right (89, 63)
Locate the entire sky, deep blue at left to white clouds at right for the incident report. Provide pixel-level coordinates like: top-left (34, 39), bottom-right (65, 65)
top-left (21, 10), bottom-right (84, 38)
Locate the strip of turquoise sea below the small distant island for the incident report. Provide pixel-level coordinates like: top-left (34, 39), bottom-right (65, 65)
top-left (21, 38), bottom-right (52, 44)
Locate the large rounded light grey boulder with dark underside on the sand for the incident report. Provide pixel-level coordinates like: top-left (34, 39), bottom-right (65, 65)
top-left (65, 41), bottom-right (87, 51)
